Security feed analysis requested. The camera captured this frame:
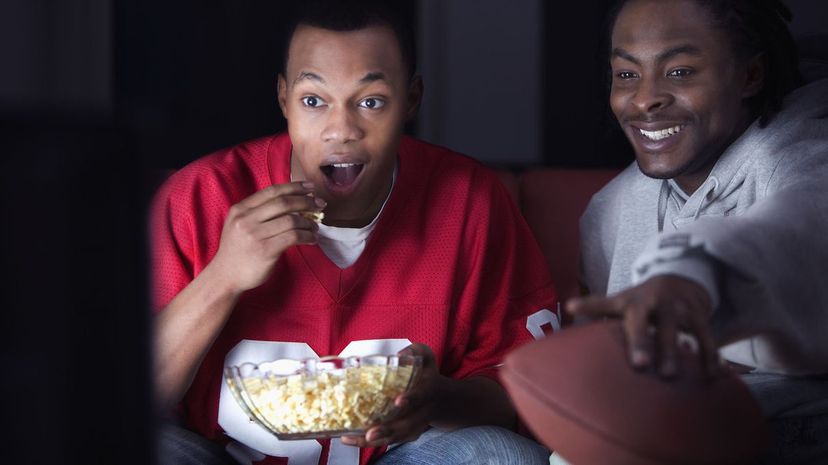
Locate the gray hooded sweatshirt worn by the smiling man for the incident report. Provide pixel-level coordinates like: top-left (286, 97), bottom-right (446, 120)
top-left (581, 80), bottom-right (828, 415)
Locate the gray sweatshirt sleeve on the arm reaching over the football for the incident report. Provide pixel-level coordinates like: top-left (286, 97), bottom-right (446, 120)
top-left (633, 141), bottom-right (828, 374)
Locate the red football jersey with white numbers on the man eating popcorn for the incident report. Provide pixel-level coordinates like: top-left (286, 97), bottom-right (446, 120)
top-left (151, 134), bottom-right (556, 465)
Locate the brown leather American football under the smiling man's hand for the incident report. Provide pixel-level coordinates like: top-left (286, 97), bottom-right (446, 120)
top-left (501, 320), bottom-right (768, 465)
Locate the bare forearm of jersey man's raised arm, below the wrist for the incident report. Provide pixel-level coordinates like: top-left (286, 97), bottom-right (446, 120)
top-left (153, 266), bottom-right (240, 406)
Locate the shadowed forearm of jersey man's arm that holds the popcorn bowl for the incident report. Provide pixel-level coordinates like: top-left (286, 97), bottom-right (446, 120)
top-left (430, 376), bottom-right (517, 430)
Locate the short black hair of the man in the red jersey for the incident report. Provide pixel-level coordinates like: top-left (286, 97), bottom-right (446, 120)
top-left (282, 0), bottom-right (417, 77)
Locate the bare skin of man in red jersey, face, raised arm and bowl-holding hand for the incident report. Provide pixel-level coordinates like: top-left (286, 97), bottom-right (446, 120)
top-left (154, 26), bottom-right (516, 438)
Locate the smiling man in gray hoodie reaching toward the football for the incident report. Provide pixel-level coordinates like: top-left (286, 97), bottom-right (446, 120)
top-left (567, 0), bottom-right (828, 463)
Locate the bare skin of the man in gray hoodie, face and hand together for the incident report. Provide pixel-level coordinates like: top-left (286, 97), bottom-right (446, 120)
top-left (566, 0), bottom-right (764, 377)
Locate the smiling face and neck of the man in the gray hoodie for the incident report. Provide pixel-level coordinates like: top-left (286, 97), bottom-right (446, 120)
top-left (610, 0), bottom-right (763, 194)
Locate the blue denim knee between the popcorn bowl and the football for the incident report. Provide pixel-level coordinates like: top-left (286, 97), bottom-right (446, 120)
top-left (376, 426), bottom-right (549, 465)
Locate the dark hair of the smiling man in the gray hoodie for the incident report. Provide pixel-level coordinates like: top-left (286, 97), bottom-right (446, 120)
top-left (606, 0), bottom-right (802, 126)
